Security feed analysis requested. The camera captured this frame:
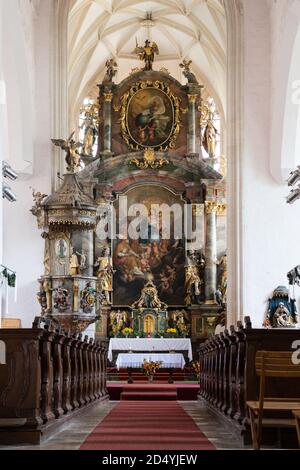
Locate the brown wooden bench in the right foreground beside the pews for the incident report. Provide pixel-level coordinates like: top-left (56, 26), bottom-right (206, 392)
top-left (247, 351), bottom-right (300, 449)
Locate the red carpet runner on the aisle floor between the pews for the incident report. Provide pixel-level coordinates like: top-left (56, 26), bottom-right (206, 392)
top-left (81, 401), bottom-right (215, 450)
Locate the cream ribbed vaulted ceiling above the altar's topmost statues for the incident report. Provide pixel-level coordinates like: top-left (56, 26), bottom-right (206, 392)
top-left (68, 0), bottom-right (226, 123)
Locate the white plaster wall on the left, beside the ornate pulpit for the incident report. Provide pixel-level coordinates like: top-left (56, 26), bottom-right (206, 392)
top-left (1, 0), bottom-right (52, 327)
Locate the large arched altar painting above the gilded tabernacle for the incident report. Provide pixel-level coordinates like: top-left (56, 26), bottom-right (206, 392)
top-left (113, 185), bottom-right (185, 306)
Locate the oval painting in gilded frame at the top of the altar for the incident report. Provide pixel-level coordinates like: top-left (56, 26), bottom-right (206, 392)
top-left (127, 87), bottom-right (174, 147)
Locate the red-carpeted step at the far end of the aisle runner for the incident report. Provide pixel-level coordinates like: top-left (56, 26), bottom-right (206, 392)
top-left (120, 384), bottom-right (177, 401)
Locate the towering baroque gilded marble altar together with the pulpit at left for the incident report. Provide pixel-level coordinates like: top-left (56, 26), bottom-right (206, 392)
top-left (32, 41), bottom-right (227, 341)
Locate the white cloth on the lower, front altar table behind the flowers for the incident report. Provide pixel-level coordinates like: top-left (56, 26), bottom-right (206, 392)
top-left (116, 353), bottom-right (185, 370)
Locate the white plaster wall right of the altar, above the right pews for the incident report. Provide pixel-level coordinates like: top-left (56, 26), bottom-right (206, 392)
top-left (241, 0), bottom-right (300, 326)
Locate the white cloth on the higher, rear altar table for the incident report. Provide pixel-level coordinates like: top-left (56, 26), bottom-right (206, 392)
top-left (108, 338), bottom-right (193, 361)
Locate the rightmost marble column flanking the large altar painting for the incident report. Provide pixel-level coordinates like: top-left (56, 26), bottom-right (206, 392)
top-left (204, 201), bottom-right (218, 304)
